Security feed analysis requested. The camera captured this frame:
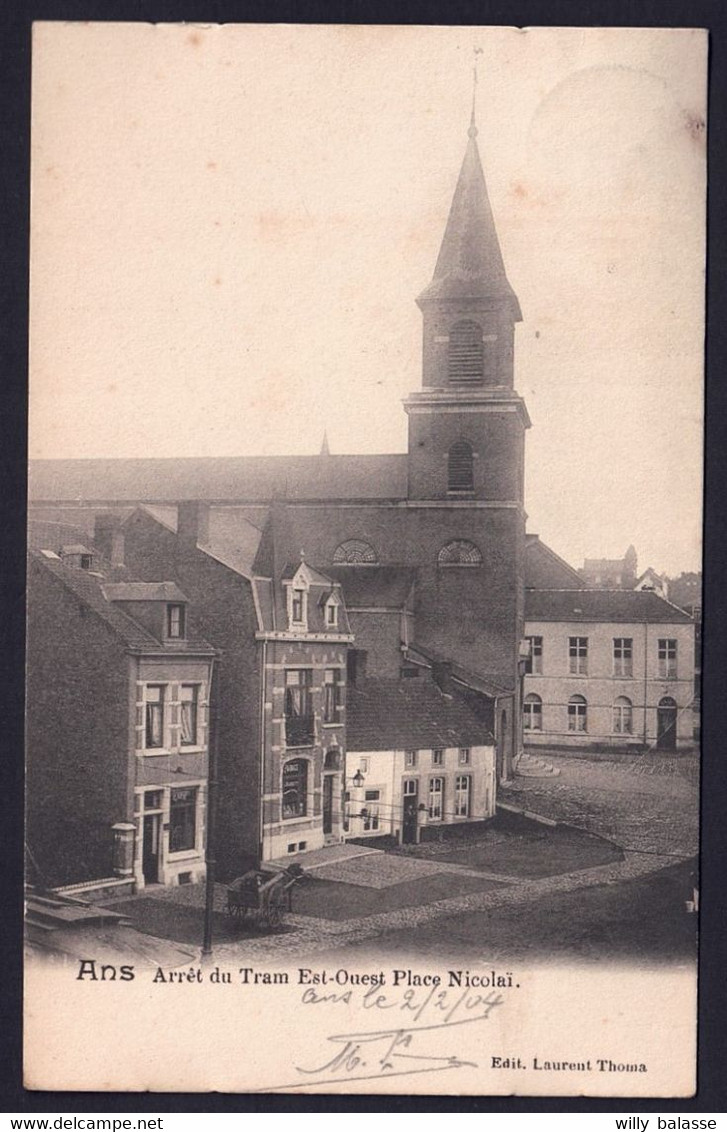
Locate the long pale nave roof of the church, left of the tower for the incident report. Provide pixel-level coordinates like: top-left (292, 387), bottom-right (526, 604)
top-left (28, 454), bottom-right (407, 504)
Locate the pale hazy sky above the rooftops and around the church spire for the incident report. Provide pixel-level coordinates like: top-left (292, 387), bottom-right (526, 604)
top-left (31, 23), bottom-right (707, 575)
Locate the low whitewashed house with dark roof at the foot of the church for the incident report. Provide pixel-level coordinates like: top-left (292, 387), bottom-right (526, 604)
top-left (343, 674), bottom-right (496, 844)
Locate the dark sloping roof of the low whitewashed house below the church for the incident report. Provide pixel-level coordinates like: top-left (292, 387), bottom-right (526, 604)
top-left (347, 677), bottom-right (493, 752)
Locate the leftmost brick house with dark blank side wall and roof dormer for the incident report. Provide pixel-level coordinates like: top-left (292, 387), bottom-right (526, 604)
top-left (26, 541), bottom-right (215, 891)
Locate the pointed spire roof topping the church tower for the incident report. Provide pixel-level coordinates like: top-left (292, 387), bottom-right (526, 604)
top-left (418, 121), bottom-right (522, 321)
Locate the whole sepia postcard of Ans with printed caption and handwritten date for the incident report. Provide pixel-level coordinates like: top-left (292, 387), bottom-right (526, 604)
top-left (25, 23), bottom-right (708, 1097)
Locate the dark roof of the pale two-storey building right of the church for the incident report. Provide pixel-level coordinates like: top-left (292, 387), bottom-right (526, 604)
top-left (525, 590), bottom-right (692, 624)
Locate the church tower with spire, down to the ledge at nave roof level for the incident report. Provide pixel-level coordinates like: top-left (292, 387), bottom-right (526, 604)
top-left (404, 112), bottom-right (530, 505)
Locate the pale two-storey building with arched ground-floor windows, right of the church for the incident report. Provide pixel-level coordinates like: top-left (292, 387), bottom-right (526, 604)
top-left (523, 589), bottom-right (694, 751)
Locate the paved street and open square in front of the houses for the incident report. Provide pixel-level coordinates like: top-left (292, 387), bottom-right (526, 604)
top-left (106, 754), bottom-right (698, 962)
